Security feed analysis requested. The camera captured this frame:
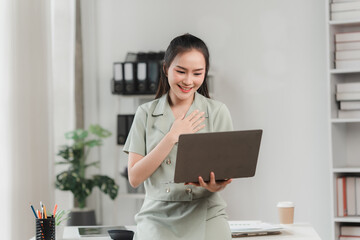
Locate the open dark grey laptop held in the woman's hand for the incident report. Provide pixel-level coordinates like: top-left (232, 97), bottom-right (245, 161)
top-left (174, 129), bottom-right (263, 183)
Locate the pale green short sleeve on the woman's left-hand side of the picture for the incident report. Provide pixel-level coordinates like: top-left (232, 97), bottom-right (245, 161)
top-left (123, 106), bottom-right (147, 156)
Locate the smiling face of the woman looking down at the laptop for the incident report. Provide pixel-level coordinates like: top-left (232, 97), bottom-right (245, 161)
top-left (167, 49), bottom-right (206, 104)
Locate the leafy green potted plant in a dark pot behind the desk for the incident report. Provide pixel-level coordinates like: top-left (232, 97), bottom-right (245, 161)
top-left (55, 125), bottom-right (119, 225)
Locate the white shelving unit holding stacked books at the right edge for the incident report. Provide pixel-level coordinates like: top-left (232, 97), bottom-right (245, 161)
top-left (326, 0), bottom-right (360, 240)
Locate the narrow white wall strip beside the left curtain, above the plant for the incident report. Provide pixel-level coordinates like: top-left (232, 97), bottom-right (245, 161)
top-left (51, 0), bottom-right (75, 214)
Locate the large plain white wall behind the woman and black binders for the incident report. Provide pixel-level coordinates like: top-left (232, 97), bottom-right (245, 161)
top-left (83, 0), bottom-right (331, 239)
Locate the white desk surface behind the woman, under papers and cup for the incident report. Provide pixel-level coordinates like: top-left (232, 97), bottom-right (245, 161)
top-left (31, 223), bottom-right (321, 240)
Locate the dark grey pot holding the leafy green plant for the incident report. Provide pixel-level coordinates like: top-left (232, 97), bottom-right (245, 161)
top-left (68, 208), bottom-right (96, 226)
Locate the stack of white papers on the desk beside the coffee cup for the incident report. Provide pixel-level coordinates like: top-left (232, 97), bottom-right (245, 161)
top-left (229, 221), bottom-right (283, 237)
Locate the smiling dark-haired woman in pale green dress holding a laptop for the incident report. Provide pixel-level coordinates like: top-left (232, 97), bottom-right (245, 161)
top-left (124, 34), bottom-right (232, 240)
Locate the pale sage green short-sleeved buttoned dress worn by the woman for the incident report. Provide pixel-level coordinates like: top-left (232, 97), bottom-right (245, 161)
top-left (124, 93), bottom-right (233, 240)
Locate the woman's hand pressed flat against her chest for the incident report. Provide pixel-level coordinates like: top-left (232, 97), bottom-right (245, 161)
top-left (169, 110), bottom-right (205, 142)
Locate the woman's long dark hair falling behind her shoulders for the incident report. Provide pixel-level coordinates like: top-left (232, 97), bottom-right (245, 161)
top-left (155, 33), bottom-right (210, 99)
